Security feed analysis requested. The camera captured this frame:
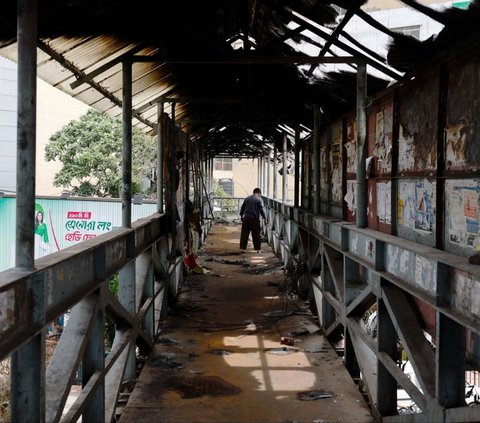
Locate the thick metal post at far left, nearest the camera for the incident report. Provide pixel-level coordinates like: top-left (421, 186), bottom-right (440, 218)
top-left (11, 0), bottom-right (45, 422)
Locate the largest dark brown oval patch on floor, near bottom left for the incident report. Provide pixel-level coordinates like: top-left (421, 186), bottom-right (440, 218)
top-left (165, 376), bottom-right (242, 399)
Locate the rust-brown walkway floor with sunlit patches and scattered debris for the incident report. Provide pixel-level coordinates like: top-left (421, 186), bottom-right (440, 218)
top-left (120, 224), bottom-right (373, 423)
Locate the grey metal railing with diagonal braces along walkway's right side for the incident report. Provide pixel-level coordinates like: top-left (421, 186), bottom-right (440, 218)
top-left (266, 200), bottom-right (480, 422)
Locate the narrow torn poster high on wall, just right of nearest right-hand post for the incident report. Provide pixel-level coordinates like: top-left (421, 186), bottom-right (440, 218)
top-left (373, 104), bottom-right (393, 172)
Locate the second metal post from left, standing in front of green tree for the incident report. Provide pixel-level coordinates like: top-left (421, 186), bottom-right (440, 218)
top-left (118, 61), bottom-right (136, 380)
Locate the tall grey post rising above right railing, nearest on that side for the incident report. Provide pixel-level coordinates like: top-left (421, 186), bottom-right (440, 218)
top-left (355, 62), bottom-right (367, 228)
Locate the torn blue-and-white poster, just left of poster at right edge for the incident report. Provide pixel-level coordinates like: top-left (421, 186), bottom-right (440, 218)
top-left (398, 179), bottom-right (435, 233)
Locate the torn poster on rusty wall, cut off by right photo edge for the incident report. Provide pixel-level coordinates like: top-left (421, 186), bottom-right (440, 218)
top-left (445, 179), bottom-right (480, 249)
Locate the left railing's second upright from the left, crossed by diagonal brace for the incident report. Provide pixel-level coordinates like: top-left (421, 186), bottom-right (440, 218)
top-left (82, 292), bottom-right (105, 422)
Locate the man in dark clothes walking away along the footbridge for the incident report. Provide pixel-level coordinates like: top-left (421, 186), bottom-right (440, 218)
top-left (240, 188), bottom-right (268, 253)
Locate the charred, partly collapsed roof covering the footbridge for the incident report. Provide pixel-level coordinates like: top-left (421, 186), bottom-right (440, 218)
top-left (0, 0), bottom-right (480, 156)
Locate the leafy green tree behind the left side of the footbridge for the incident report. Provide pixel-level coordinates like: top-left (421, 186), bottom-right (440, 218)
top-left (45, 109), bottom-right (156, 197)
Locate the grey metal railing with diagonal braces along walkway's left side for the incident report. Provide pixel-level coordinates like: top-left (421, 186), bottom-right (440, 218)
top-left (0, 214), bottom-right (183, 422)
